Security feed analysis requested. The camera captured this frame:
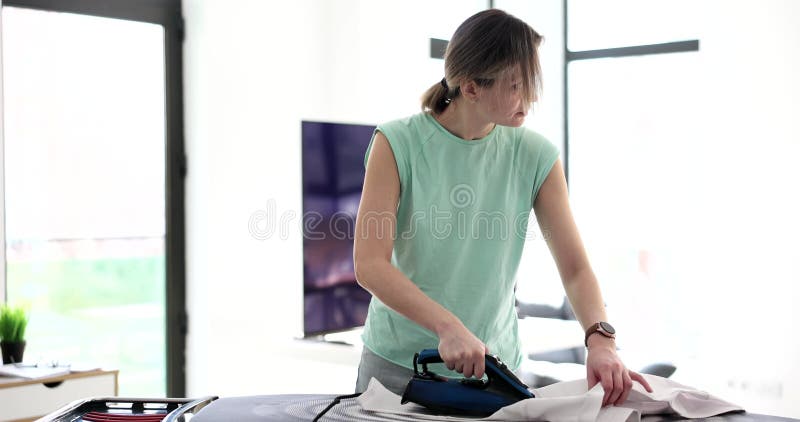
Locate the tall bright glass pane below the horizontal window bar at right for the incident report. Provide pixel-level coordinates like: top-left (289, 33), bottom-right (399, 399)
top-left (569, 53), bottom-right (704, 368)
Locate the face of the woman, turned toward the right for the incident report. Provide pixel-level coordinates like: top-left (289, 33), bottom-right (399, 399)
top-left (477, 68), bottom-right (531, 127)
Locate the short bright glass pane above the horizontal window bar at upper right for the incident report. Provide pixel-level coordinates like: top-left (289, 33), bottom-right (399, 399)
top-left (567, 0), bottom-right (708, 51)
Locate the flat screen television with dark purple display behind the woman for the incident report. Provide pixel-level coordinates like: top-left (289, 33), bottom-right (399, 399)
top-left (302, 121), bottom-right (375, 337)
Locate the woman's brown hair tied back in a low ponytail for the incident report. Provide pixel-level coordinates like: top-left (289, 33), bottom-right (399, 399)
top-left (422, 9), bottom-right (543, 114)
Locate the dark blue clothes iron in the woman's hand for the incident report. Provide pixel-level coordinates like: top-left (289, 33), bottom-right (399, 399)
top-left (400, 349), bottom-right (534, 416)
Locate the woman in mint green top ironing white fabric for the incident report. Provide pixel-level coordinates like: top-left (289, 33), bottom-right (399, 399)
top-left (353, 9), bottom-right (650, 406)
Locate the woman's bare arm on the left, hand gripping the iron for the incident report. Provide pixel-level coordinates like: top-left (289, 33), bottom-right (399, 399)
top-left (353, 132), bottom-right (488, 377)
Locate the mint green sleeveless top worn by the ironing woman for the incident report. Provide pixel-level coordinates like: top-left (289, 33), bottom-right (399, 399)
top-left (362, 113), bottom-right (559, 377)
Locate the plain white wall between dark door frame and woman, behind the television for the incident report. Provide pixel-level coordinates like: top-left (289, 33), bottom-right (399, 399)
top-left (183, 0), bottom-right (558, 395)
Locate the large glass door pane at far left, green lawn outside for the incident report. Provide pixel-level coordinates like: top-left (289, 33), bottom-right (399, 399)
top-left (2, 7), bottom-right (166, 396)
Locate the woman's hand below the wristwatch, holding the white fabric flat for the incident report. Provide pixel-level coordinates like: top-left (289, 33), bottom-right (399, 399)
top-left (586, 335), bottom-right (653, 407)
